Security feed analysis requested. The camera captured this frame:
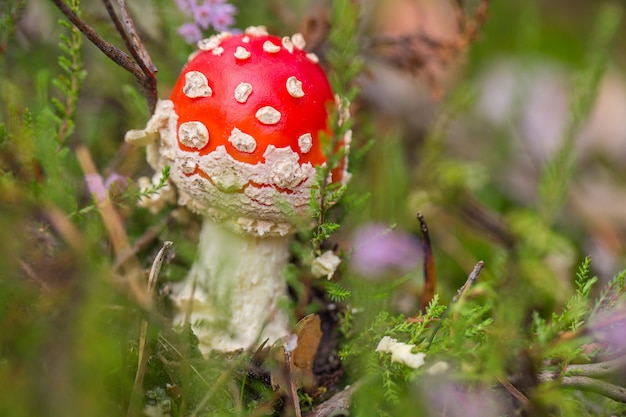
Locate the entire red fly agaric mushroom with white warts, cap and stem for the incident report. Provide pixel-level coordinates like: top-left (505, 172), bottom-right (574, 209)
top-left (126, 27), bottom-right (350, 355)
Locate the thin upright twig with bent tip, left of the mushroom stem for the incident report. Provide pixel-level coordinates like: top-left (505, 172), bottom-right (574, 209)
top-left (126, 241), bottom-right (173, 417)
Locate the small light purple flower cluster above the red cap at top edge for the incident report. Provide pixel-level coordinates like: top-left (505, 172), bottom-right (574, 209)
top-left (175, 0), bottom-right (237, 43)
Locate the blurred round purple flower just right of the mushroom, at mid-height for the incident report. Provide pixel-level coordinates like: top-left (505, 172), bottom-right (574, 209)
top-left (350, 224), bottom-right (422, 277)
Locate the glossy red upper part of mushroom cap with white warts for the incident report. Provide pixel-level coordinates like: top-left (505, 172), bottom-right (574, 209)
top-left (171, 28), bottom-right (343, 176)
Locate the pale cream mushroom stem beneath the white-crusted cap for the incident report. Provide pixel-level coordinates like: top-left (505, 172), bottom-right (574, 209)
top-left (173, 218), bottom-right (291, 356)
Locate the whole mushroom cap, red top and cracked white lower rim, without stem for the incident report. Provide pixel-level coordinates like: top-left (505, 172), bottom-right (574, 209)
top-left (149, 27), bottom-right (350, 235)
